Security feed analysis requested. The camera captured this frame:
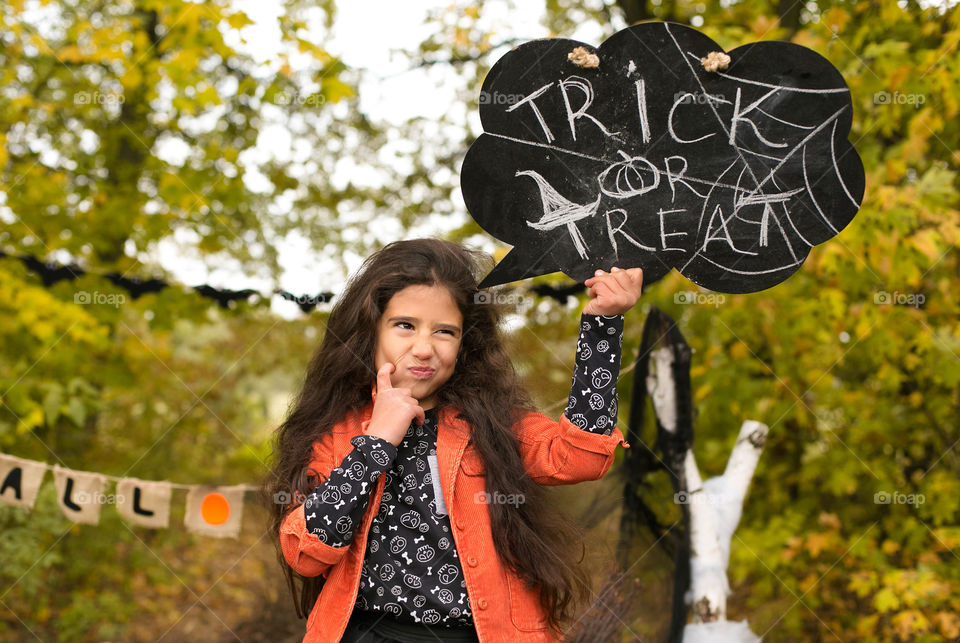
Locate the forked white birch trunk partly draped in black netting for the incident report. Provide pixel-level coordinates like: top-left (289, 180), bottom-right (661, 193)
top-left (618, 307), bottom-right (767, 643)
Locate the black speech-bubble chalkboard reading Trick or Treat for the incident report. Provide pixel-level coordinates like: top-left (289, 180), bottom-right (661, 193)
top-left (461, 22), bottom-right (864, 293)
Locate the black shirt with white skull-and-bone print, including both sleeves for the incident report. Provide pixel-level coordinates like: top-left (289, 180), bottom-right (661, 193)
top-left (304, 314), bottom-right (623, 627)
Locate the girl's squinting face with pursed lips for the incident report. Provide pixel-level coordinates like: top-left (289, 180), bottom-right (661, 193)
top-left (375, 285), bottom-right (463, 410)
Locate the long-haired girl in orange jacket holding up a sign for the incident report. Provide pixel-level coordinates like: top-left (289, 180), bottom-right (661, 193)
top-left (264, 239), bottom-right (643, 643)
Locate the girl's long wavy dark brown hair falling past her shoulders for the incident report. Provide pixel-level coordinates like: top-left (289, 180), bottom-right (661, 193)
top-left (261, 239), bottom-right (590, 634)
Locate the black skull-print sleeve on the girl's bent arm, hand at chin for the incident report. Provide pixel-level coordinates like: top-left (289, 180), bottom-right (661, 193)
top-left (303, 435), bottom-right (397, 547)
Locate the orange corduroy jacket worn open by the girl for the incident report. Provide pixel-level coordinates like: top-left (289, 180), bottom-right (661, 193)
top-left (280, 384), bottom-right (630, 643)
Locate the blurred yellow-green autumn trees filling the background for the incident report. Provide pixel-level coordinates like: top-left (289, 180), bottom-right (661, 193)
top-left (0, 0), bottom-right (960, 641)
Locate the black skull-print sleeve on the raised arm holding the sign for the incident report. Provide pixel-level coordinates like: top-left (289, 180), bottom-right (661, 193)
top-left (563, 313), bottom-right (623, 435)
